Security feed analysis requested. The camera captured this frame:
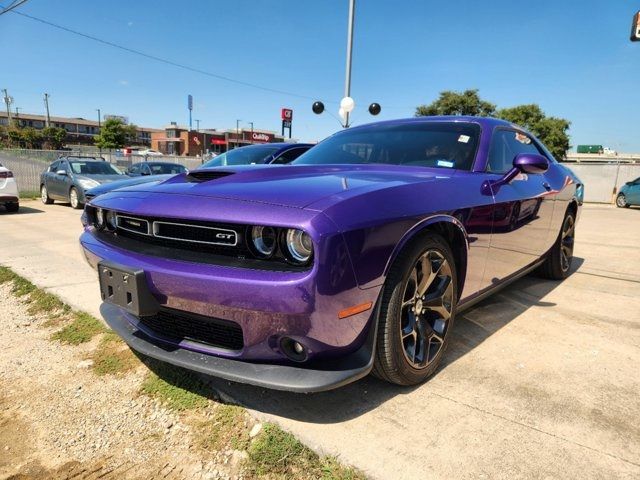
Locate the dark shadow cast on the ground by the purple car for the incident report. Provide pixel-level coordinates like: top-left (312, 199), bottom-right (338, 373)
top-left (145, 257), bottom-right (584, 423)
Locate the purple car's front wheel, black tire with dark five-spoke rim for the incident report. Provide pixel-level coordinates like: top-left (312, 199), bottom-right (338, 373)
top-left (373, 233), bottom-right (457, 385)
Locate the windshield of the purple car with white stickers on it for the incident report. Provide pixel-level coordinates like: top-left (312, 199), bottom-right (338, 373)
top-left (293, 122), bottom-right (480, 170)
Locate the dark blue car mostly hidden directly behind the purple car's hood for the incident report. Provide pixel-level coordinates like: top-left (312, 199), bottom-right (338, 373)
top-left (200, 143), bottom-right (313, 168)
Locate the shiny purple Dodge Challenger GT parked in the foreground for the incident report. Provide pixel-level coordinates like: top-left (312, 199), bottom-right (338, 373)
top-left (80, 117), bottom-right (583, 392)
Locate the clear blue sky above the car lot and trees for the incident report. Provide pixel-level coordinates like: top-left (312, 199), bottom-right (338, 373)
top-left (0, 0), bottom-right (640, 152)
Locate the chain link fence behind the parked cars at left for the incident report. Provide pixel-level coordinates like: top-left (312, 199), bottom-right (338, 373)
top-left (0, 149), bottom-right (204, 196)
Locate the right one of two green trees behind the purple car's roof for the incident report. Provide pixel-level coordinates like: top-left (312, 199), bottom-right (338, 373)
top-left (496, 104), bottom-right (571, 160)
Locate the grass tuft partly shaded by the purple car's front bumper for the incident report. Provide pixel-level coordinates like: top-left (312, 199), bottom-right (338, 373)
top-left (141, 364), bottom-right (208, 411)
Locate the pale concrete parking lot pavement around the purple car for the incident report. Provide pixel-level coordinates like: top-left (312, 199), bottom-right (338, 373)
top-left (0, 201), bottom-right (640, 478)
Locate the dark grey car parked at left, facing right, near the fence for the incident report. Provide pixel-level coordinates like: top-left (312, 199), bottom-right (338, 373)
top-left (40, 156), bottom-right (124, 208)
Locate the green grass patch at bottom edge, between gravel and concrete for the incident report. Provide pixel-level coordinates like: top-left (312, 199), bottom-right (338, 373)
top-left (246, 423), bottom-right (366, 480)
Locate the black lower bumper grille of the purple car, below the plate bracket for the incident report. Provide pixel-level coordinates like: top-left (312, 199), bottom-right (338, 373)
top-left (140, 308), bottom-right (244, 350)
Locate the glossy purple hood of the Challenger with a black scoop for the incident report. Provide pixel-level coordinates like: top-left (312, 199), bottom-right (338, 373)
top-left (122, 165), bottom-right (454, 208)
